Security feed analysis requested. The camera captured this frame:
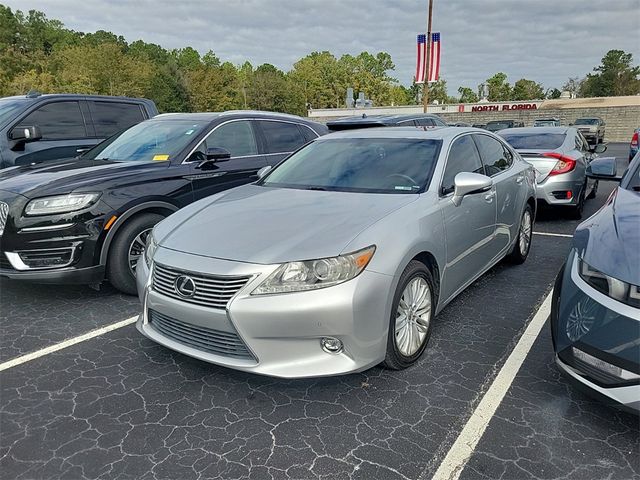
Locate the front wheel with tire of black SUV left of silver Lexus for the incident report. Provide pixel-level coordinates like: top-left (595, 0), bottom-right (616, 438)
top-left (107, 213), bottom-right (164, 295)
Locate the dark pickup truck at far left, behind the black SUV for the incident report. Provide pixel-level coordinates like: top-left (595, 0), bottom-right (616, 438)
top-left (0, 92), bottom-right (158, 168)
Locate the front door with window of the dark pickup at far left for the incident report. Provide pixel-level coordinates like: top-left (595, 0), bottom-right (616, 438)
top-left (7, 100), bottom-right (98, 165)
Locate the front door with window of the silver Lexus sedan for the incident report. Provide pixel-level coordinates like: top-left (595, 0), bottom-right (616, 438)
top-left (438, 134), bottom-right (496, 300)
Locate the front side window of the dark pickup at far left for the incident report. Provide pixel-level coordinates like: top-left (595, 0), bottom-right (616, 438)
top-left (17, 102), bottom-right (87, 140)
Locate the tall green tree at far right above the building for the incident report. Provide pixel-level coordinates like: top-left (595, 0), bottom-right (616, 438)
top-left (580, 50), bottom-right (640, 97)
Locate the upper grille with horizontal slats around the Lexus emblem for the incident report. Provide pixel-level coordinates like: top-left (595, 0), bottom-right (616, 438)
top-left (153, 263), bottom-right (251, 309)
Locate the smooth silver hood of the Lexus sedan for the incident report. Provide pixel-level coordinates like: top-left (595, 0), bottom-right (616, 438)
top-left (155, 185), bottom-right (418, 264)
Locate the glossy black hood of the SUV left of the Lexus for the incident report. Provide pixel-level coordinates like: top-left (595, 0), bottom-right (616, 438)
top-left (0, 158), bottom-right (168, 198)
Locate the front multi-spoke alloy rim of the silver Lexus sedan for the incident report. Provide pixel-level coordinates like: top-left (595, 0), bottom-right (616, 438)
top-left (395, 277), bottom-right (431, 357)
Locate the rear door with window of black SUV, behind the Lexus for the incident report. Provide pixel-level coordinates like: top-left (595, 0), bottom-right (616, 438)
top-left (256, 119), bottom-right (317, 166)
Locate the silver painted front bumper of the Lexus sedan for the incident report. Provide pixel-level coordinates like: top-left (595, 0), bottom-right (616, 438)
top-left (137, 248), bottom-right (394, 378)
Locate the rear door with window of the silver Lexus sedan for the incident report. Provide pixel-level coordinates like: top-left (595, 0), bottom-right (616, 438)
top-left (473, 134), bottom-right (526, 256)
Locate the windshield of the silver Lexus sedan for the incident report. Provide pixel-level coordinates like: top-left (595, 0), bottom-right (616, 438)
top-left (261, 138), bottom-right (442, 194)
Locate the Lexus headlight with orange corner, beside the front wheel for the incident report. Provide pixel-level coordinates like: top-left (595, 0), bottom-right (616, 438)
top-left (251, 245), bottom-right (376, 295)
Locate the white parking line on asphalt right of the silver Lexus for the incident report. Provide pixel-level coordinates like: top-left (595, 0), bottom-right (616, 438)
top-left (421, 291), bottom-right (553, 480)
